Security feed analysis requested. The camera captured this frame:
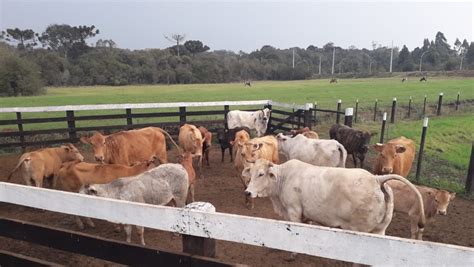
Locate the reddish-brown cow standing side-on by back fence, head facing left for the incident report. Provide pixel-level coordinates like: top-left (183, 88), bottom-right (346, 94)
top-left (81, 127), bottom-right (177, 166)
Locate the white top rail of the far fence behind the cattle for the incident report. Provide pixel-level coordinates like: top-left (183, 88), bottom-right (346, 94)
top-left (0, 100), bottom-right (312, 113)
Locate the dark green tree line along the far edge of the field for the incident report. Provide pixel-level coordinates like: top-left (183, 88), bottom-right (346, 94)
top-left (0, 24), bottom-right (474, 96)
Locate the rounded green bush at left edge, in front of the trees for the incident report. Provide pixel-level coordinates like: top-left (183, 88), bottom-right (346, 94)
top-left (0, 51), bottom-right (46, 96)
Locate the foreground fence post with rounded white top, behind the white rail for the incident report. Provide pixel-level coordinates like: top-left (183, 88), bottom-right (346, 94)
top-left (182, 202), bottom-right (216, 258)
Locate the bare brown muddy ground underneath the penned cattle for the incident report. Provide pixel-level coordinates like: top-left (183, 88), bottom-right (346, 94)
top-left (0, 145), bottom-right (474, 266)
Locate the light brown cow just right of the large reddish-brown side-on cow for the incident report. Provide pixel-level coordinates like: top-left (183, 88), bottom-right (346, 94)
top-left (178, 123), bottom-right (204, 178)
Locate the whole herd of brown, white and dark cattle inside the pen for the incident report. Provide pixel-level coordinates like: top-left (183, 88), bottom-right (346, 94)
top-left (3, 109), bottom-right (455, 250)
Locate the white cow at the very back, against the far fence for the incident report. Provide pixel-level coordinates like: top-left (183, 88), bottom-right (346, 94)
top-left (227, 108), bottom-right (271, 136)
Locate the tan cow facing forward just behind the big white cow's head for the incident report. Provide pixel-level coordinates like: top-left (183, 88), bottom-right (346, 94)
top-left (235, 134), bottom-right (280, 209)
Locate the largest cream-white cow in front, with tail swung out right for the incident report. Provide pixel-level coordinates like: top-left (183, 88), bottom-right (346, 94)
top-left (243, 159), bottom-right (424, 257)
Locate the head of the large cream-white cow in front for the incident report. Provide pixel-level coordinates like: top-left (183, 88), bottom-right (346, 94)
top-left (242, 159), bottom-right (277, 198)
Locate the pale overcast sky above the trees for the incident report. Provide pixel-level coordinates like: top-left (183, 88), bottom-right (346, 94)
top-left (0, 0), bottom-right (474, 52)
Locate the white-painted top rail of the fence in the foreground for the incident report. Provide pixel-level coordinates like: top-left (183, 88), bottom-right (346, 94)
top-left (0, 182), bottom-right (474, 266)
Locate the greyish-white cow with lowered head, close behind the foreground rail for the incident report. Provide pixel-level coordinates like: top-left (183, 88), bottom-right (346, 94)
top-left (80, 163), bottom-right (189, 245)
